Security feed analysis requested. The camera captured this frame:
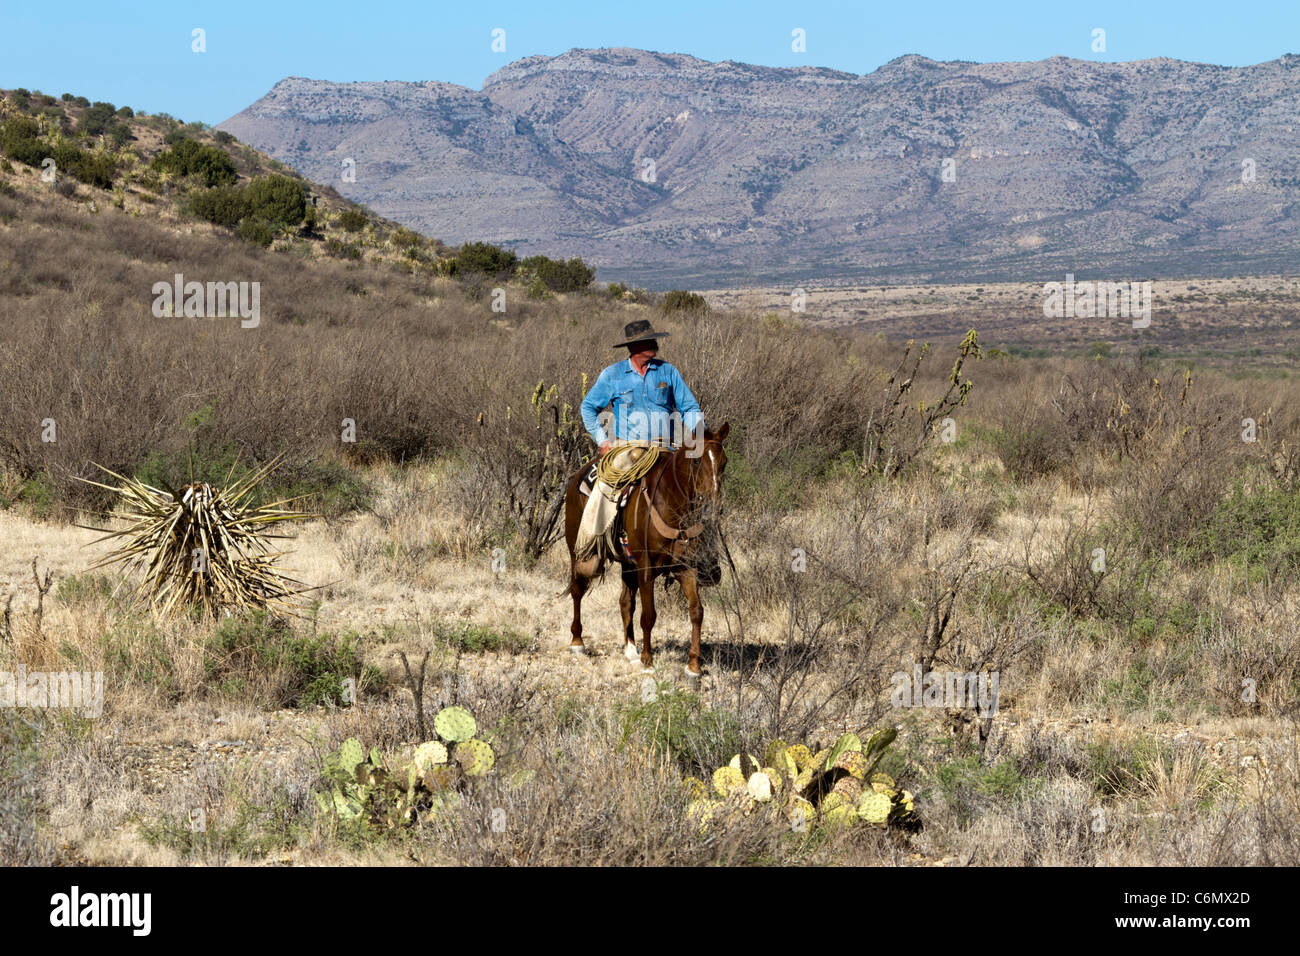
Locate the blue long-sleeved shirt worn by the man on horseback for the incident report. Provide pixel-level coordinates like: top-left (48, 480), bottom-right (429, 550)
top-left (582, 358), bottom-right (705, 445)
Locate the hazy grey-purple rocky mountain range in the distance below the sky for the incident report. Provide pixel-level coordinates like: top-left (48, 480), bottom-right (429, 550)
top-left (221, 49), bottom-right (1300, 286)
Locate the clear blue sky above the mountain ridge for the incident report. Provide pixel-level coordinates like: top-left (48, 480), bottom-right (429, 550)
top-left (0, 0), bottom-right (1300, 124)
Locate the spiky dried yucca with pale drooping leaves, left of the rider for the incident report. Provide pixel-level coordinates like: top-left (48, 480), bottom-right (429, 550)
top-left (78, 458), bottom-right (311, 617)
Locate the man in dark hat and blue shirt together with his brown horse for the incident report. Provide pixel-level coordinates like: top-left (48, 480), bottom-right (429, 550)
top-left (564, 320), bottom-right (728, 678)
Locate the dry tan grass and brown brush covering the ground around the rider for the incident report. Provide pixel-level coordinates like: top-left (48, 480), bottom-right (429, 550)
top-left (0, 108), bottom-right (1300, 865)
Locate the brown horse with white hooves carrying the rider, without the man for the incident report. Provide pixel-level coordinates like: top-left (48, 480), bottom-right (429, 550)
top-left (564, 424), bottom-right (729, 678)
